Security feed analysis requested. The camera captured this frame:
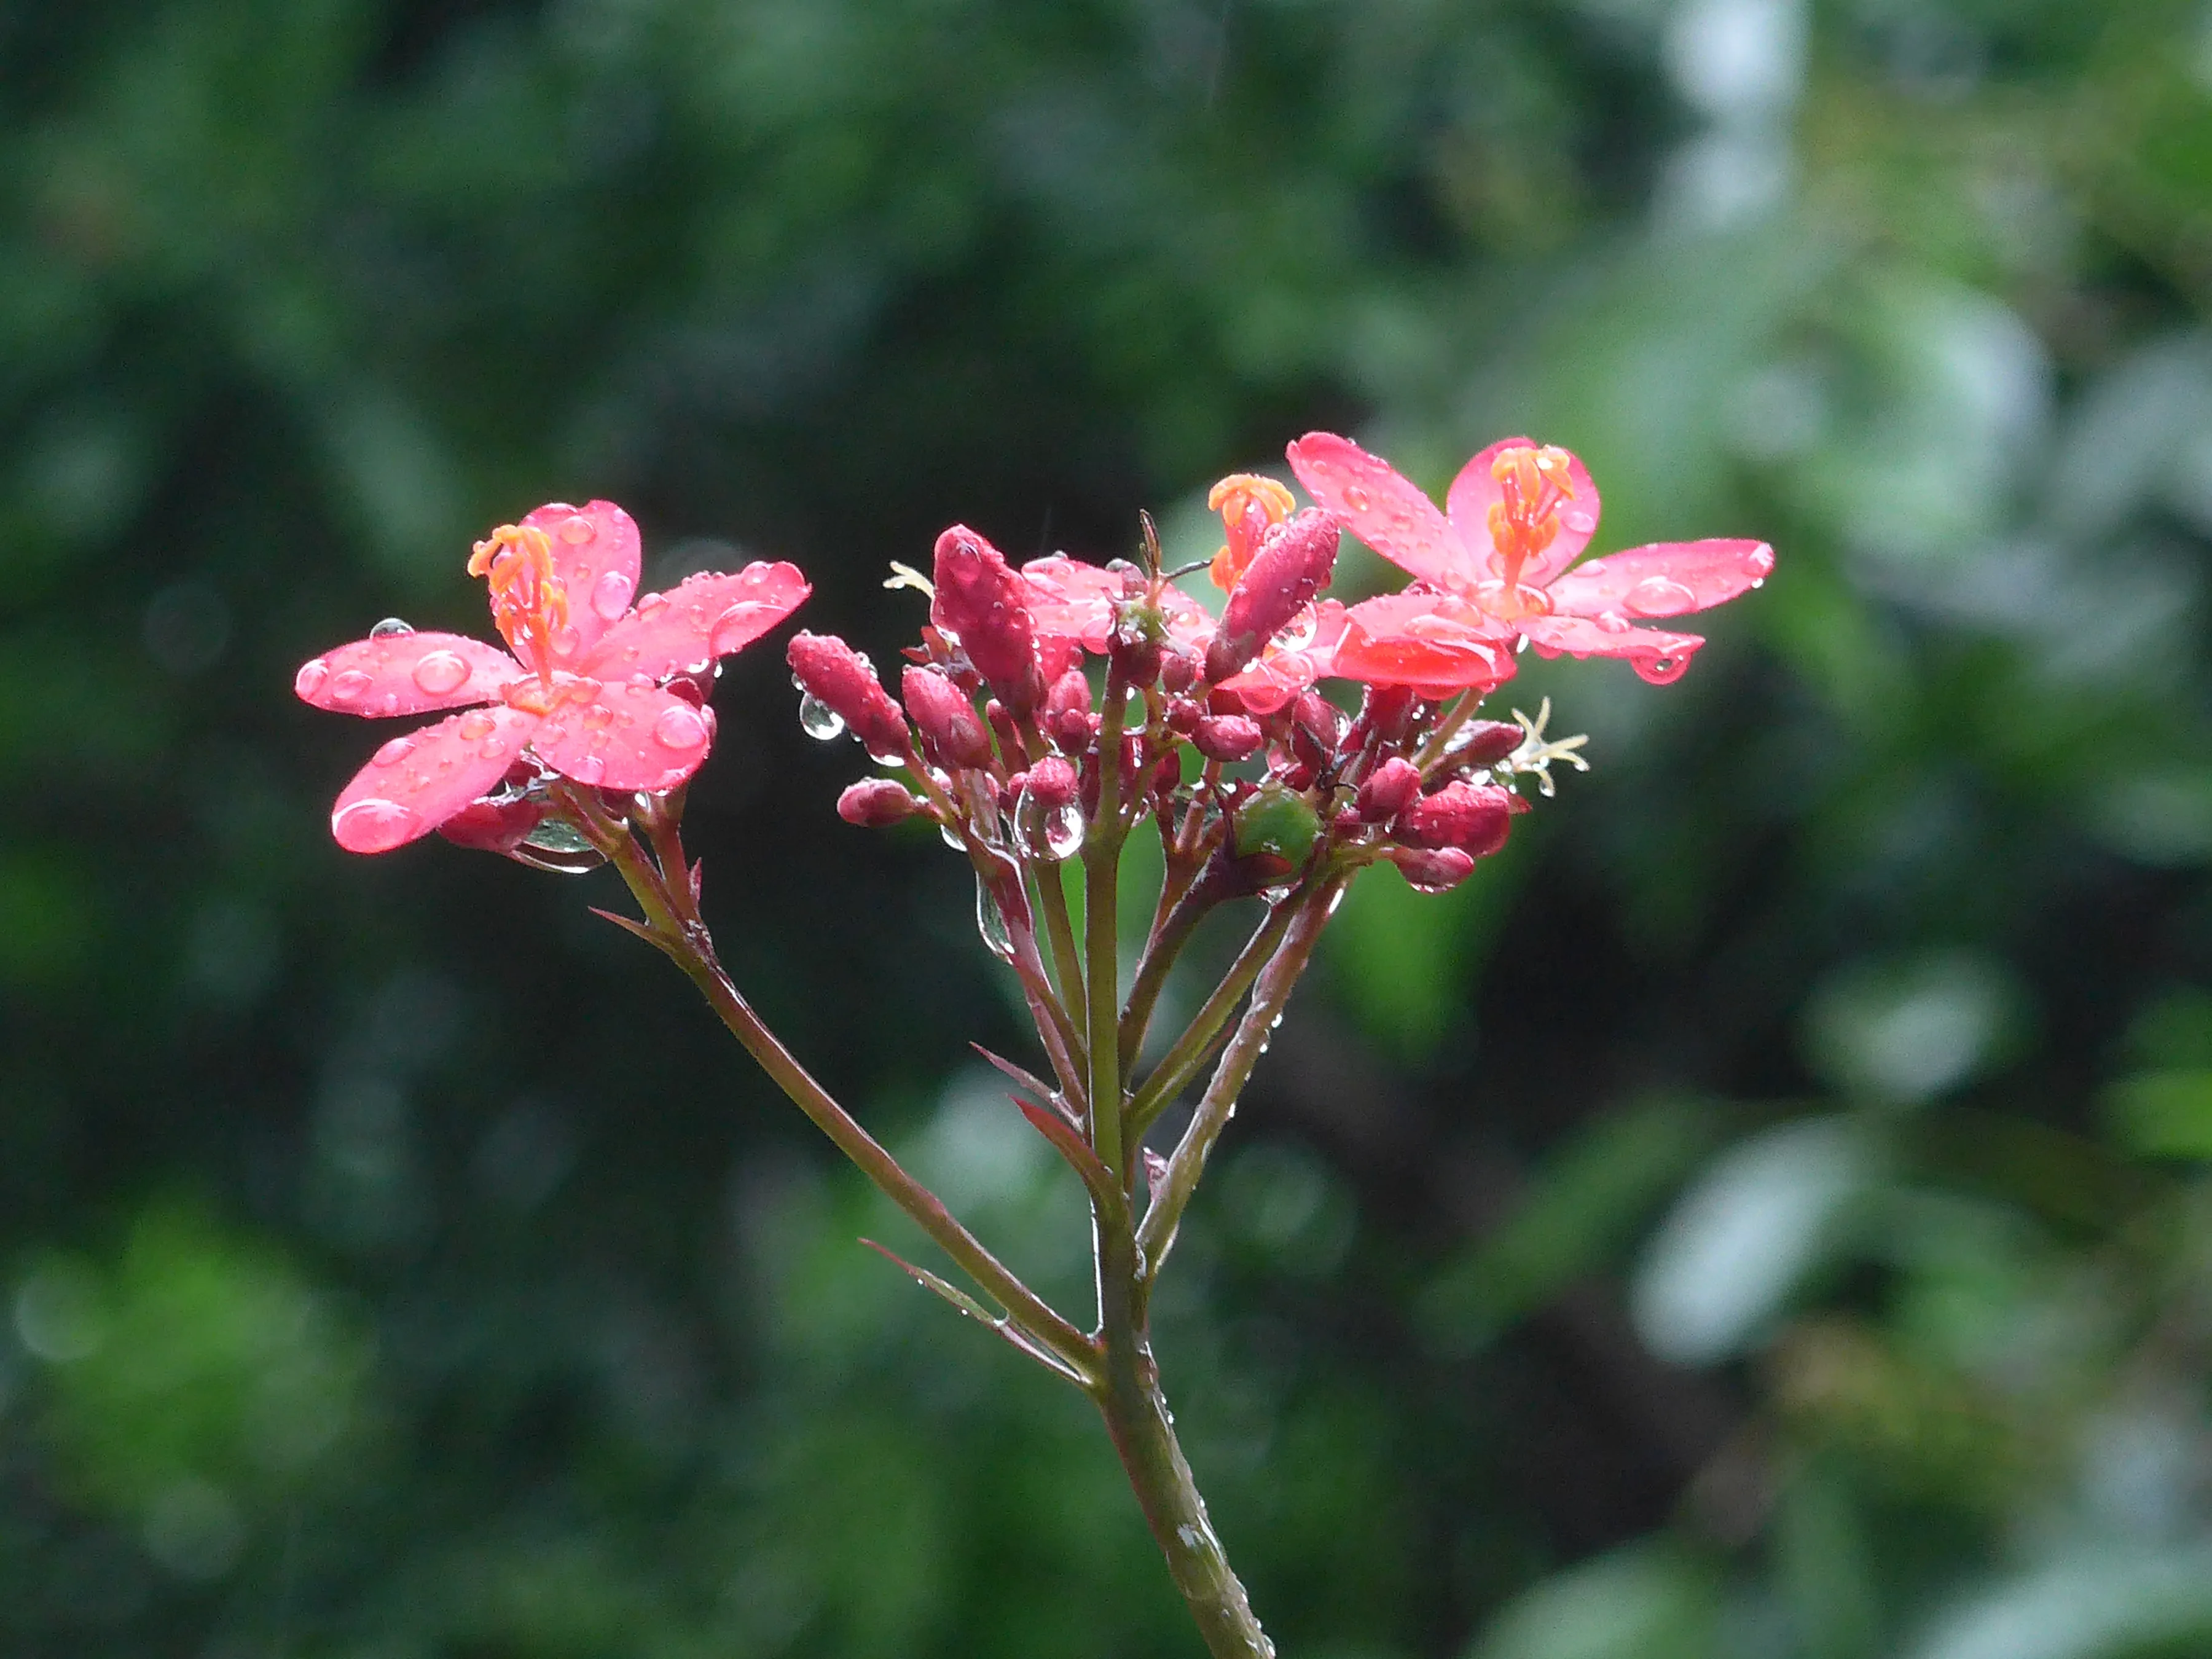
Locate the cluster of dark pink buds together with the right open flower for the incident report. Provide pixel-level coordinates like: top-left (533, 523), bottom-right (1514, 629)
top-left (790, 434), bottom-right (1774, 898)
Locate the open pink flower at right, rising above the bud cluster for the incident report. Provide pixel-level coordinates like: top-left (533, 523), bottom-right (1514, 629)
top-left (1290, 431), bottom-right (1774, 686)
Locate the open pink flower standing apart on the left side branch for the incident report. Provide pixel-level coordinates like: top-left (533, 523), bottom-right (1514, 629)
top-left (292, 502), bottom-right (810, 852)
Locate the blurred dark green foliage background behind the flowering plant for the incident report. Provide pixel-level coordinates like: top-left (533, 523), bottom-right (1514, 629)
top-left (0, 0), bottom-right (2212, 1659)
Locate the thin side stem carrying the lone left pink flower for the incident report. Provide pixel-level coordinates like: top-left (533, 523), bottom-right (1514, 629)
top-left (557, 785), bottom-right (1099, 1378)
